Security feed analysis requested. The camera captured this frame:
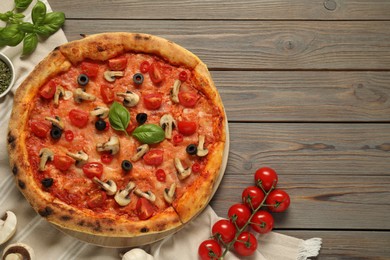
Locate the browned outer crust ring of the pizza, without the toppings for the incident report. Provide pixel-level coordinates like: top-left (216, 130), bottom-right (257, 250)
top-left (8, 33), bottom-right (226, 246)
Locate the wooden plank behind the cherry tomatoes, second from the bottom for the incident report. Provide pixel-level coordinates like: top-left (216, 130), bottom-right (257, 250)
top-left (211, 175), bottom-right (390, 230)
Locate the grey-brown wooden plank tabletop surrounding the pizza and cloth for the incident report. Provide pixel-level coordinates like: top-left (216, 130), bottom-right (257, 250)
top-left (49, 0), bottom-right (390, 260)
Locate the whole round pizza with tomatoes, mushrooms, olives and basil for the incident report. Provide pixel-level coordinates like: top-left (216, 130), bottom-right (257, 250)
top-left (8, 32), bottom-right (226, 244)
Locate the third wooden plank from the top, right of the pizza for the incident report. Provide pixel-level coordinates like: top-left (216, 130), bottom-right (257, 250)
top-left (212, 71), bottom-right (390, 122)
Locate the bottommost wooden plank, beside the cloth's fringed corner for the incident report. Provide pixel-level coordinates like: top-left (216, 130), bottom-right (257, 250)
top-left (280, 231), bottom-right (390, 260)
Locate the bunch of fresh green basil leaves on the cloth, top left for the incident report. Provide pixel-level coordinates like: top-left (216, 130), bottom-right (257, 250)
top-left (0, 0), bottom-right (65, 55)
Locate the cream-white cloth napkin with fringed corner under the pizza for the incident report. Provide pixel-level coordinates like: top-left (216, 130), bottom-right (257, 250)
top-left (0, 0), bottom-right (321, 260)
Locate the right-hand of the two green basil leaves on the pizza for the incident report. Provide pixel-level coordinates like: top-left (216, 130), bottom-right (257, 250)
top-left (133, 124), bottom-right (165, 144)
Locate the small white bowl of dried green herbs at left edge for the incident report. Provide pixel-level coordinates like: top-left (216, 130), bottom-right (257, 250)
top-left (0, 52), bottom-right (15, 98)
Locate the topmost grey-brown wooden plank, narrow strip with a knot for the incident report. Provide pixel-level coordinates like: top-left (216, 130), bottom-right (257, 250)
top-left (50, 0), bottom-right (390, 20)
